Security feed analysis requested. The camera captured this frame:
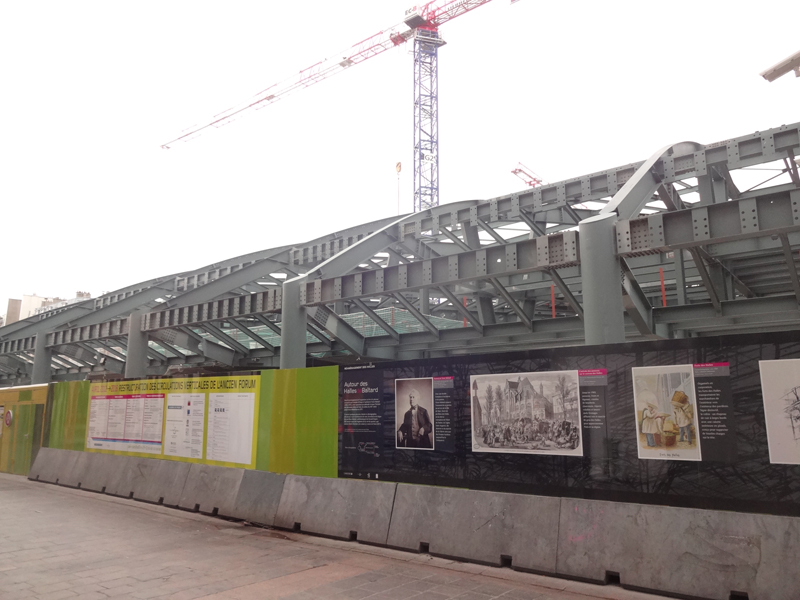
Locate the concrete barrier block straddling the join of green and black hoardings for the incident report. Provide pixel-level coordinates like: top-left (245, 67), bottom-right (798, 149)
top-left (275, 475), bottom-right (397, 544)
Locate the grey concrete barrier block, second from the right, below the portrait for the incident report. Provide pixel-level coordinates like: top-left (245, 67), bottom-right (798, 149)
top-left (388, 484), bottom-right (560, 573)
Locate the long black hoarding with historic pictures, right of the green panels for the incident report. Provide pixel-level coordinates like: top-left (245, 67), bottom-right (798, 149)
top-left (339, 332), bottom-right (800, 515)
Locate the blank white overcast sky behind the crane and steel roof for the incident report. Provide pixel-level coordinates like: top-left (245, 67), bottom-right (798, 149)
top-left (0, 0), bottom-right (800, 314)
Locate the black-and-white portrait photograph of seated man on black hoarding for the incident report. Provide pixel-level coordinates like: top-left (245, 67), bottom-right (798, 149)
top-left (394, 377), bottom-right (434, 450)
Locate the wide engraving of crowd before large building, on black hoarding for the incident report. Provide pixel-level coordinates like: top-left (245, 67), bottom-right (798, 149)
top-left (470, 371), bottom-right (583, 456)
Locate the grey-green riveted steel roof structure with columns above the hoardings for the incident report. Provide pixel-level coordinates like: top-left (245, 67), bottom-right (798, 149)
top-left (0, 123), bottom-right (800, 386)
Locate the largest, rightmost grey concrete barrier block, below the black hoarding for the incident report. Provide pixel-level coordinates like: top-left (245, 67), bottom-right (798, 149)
top-left (556, 498), bottom-right (800, 600)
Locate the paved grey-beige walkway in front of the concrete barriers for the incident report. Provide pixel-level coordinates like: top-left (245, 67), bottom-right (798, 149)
top-left (0, 474), bottom-right (659, 600)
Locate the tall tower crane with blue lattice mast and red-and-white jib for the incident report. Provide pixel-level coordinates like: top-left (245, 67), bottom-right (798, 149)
top-left (161, 0), bottom-right (504, 212)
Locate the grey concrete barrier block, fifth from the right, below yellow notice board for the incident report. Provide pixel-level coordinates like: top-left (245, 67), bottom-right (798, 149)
top-left (178, 464), bottom-right (244, 516)
